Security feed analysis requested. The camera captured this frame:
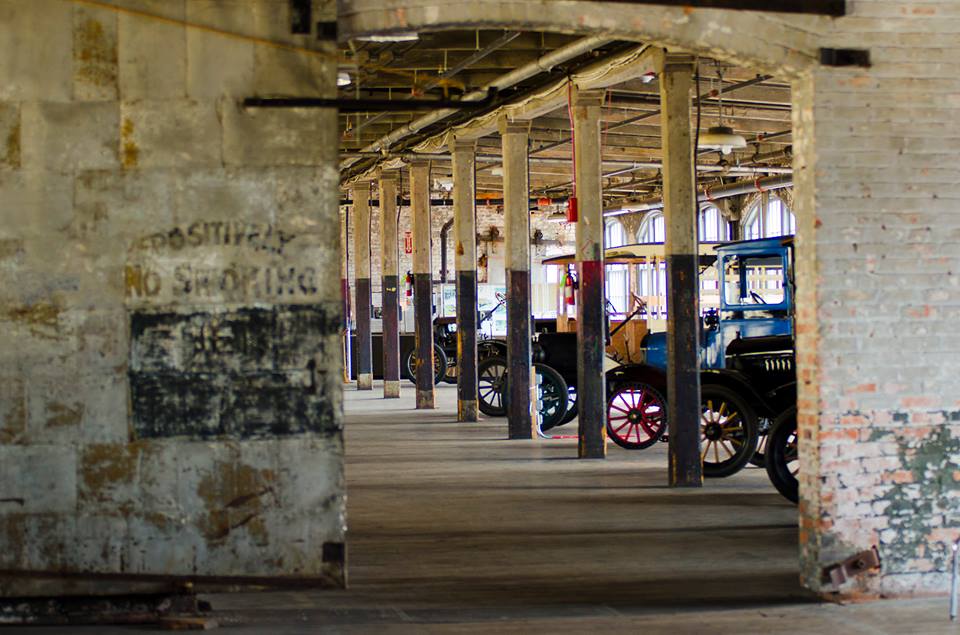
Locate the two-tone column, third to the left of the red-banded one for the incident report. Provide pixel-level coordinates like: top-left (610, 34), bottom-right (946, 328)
top-left (410, 161), bottom-right (435, 409)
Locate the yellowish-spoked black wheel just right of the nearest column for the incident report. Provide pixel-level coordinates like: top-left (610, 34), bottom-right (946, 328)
top-left (700, 386), bottom-right (757, 478)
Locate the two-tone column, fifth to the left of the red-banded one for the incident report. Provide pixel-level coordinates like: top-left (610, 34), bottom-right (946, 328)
top-left (351, 181), bottom-right (373, 390)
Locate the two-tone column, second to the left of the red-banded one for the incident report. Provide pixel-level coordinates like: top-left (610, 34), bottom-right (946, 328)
top-left (450, 139), bottom-right (477, 421)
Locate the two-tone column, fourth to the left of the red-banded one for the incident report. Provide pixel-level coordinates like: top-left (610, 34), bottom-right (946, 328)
top-left (380, 170), bottom-right (400, 398)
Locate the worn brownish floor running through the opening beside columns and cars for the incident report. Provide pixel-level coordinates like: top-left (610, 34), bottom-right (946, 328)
top-left (9, 384), bottom-right (960, 635)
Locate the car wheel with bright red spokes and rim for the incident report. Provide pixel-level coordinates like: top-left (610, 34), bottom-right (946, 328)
top-left (607, 382), bottom-right (667, 450)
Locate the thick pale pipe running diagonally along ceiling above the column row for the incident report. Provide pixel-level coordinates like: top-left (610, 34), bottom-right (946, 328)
top-left (340, 36), bottom-right (613, 170)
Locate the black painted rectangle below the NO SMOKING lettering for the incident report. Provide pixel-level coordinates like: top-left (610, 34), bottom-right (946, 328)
top-left (129, 305), bottom-right (340, 439)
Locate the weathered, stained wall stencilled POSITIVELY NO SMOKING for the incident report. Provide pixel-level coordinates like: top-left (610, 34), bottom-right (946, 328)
top-left (0, 0), bottom-right (345, 596)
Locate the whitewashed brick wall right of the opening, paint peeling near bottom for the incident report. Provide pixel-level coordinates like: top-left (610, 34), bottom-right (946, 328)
top-left (794, 0), bottom-right (960, 594)
